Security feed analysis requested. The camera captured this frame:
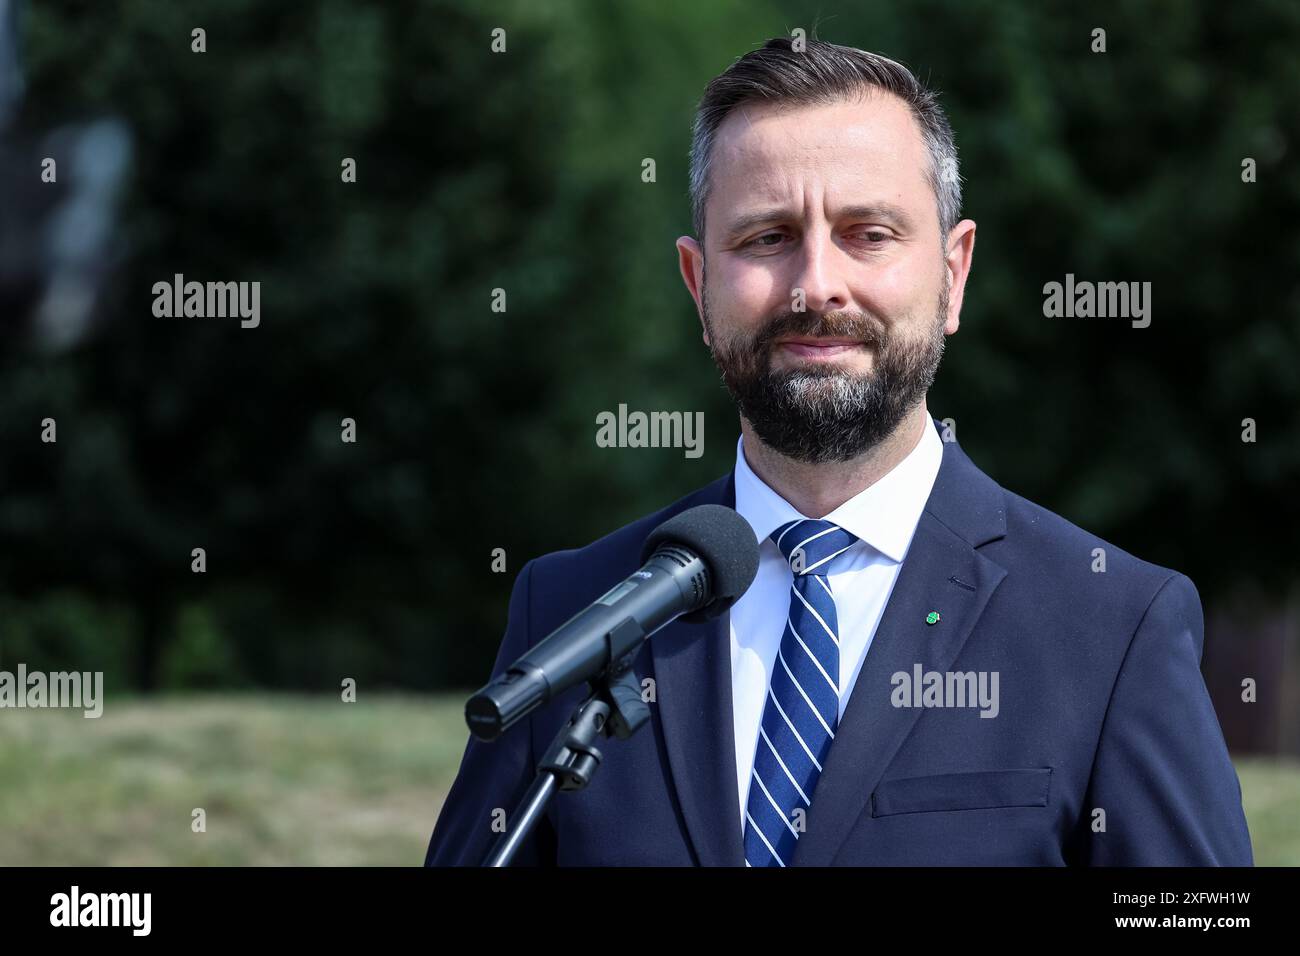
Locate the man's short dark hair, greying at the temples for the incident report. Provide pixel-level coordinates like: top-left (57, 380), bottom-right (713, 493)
top-left (690, 36), bottom-right (962, 242)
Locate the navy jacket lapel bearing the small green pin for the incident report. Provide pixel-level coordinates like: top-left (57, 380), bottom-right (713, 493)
top-left (792, 418), bottom-right (1006, 866)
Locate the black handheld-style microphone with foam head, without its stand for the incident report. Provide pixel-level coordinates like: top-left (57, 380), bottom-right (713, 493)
top-left (465, 505), bottom-right (758, 740)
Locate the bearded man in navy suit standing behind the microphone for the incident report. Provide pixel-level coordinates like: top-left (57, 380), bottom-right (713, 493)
top-left (426, 39), bottom-right (1252, 866)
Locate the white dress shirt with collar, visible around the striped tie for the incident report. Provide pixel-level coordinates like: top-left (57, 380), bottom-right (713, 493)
top-left (731, 419), bottom-right (944, 838)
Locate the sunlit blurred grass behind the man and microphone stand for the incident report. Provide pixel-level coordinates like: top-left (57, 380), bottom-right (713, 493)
top-left (0, 693), bottom-right (1300, 866)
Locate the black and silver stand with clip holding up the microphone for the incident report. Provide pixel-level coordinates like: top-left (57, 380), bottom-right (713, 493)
top-left (484, 618), bottom-right (650, 866)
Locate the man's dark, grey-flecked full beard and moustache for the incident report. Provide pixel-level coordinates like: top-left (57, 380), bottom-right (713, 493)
top-left (703, 280), bottom-right (948, 464)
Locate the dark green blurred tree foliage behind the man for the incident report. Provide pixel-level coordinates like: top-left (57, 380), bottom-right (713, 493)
top-left (0, 0), bottom-right (1300, 689)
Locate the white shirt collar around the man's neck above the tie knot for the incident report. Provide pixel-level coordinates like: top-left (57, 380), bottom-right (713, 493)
top-left (736, 418), bottom-right (944, 562)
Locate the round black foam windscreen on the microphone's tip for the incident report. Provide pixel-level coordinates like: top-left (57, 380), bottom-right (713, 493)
top-left (641, 505), bottom-right (758, 617)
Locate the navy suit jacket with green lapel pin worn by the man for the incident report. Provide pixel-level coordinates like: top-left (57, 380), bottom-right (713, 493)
top-left (425, 421), bottom-right (1252, 866)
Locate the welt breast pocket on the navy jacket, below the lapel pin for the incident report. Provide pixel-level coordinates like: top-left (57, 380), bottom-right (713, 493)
top-left (871, 767), bottom-right (1052, 817)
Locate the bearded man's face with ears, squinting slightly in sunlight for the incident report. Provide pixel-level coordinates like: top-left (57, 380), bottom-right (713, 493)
top-left (679, 92), bottom-right (974, 462)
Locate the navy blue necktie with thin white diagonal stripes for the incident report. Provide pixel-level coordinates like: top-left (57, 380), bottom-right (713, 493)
top-left (745, 518), bottom-right (858, 866)
